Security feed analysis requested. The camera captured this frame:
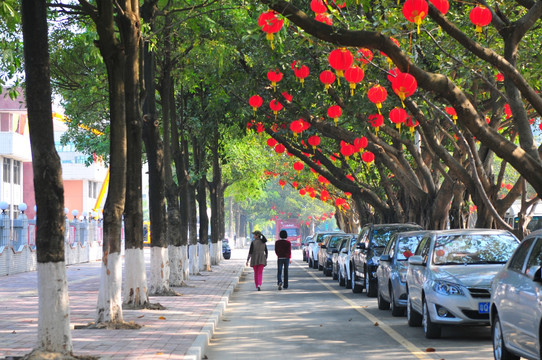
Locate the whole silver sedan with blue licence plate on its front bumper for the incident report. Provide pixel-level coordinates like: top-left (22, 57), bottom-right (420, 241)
top-left (407, 229), bottom-right (519, 339)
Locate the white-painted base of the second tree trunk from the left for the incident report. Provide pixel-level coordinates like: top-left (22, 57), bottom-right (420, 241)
top-left (96, 252), bottom-right (124, 324)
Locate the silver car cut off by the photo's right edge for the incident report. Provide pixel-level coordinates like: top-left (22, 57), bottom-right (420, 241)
top-left (490, 230), bottom-right (542, 360)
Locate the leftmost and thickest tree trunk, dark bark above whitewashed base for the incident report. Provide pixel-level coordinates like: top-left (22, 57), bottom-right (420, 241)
top-left (21, 0), bottom-right (73, 355)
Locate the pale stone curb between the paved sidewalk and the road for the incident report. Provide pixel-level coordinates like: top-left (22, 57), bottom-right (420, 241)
top-left (184, 266), bottom-right (245, 360)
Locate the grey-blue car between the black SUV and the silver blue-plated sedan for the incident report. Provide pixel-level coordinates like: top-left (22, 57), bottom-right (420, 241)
top-left (376, 230), bottom-right (426, 316)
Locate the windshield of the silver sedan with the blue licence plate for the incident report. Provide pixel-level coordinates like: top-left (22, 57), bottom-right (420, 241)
top-left (433, 234), bottom-right (519, 265)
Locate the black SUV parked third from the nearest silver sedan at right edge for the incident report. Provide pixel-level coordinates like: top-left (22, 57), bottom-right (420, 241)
top-left (350, 224), bottom-right (423, 297)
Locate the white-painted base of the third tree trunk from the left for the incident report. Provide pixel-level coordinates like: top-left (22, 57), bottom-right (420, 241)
top-left (123, 249), bottom-right (149, 308)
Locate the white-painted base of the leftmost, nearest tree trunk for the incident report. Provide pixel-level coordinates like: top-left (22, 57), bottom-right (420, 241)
top-left (37, 261), bottom-right (73, 354)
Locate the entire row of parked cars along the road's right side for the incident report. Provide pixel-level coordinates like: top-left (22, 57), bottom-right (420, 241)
top-left (302, 224), bottom-right (542, 360)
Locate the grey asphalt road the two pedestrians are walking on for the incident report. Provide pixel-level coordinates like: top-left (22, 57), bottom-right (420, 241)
top-left (205, 250), bottom-right (493, 360)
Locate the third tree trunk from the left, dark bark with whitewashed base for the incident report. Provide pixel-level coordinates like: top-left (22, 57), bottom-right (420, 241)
top-left (118, 2), bottom-right (152, 308)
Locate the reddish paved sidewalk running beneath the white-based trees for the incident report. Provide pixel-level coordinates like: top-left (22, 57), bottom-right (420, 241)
top-left (0, 248), bottom-right (248, 360)
